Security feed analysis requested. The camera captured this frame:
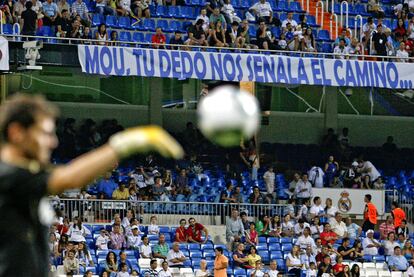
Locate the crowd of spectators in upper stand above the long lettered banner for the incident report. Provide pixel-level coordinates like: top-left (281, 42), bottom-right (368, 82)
top-left (0, 0), bottom-right (414, 57)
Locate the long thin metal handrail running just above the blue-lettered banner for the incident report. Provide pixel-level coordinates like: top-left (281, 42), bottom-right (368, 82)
top-left (3, 33), bottom-right (414, 62)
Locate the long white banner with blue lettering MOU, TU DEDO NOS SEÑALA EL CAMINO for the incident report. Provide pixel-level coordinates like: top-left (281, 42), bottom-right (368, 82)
top-left (78, 45), bottom-right (414, 89)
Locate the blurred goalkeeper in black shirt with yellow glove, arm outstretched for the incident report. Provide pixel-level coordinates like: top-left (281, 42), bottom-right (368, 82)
top-left (0, 94), bottom-right (183, 277)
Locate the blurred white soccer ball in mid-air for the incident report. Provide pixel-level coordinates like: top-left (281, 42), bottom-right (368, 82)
top-left (197, 85), bottom-right (260, 147)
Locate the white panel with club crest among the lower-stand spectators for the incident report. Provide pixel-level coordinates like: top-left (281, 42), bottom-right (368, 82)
top-left (312, 188), bottom-right (385, 215)
